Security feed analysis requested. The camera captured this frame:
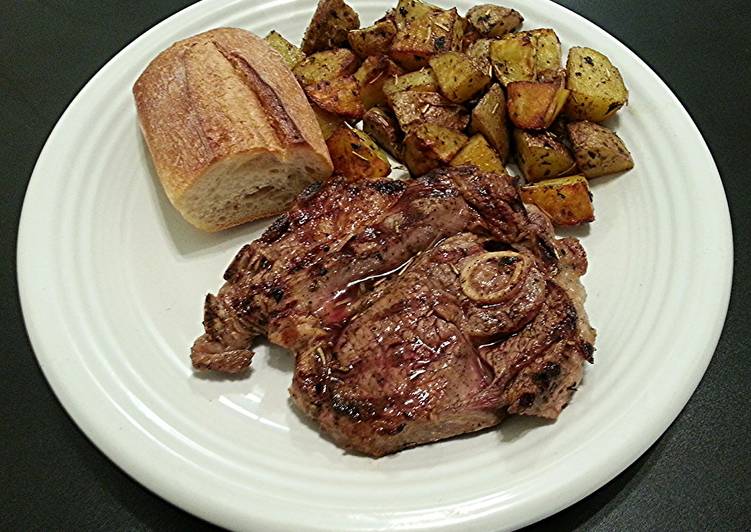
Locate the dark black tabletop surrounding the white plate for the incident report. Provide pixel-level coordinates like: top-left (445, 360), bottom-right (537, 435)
top-left (0, 0), bottom-right (751, 530)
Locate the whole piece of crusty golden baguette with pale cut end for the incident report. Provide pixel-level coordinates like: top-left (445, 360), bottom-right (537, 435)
top-left (133, 28), bottom-right (332, 231)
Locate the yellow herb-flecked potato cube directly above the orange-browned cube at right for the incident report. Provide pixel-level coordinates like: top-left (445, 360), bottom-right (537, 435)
top-left (490, 33), bottom-right (537, 86)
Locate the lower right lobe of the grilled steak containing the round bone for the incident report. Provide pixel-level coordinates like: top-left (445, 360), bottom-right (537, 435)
top-left (291, 233), bottom-right (593, 456)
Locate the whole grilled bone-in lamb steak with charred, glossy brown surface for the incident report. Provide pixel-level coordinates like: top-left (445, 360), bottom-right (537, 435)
top-left (192, 168), bottom-right (594, 456)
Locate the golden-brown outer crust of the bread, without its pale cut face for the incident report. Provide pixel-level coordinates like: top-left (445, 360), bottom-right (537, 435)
top-left (133, 28), bottom-right (332, 229)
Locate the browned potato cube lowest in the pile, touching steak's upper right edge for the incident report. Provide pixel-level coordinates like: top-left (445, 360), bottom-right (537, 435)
top-left (520, 175), bottom-right (595, 225)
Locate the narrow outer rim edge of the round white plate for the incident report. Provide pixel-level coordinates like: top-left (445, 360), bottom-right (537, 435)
top-left (16, 0), bottom-right (734, 530)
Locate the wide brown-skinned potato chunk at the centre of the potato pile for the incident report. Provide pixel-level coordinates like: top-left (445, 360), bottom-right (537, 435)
top-left (391, 91), bottom-right (469, 133)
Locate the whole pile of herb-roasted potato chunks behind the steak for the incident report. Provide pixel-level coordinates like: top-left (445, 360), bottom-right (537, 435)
top-left (266, 0), bottom-right (634, 225)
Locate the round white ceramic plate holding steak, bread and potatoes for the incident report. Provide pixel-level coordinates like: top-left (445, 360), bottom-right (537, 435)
top-left (18, 0), bottom-right (732, 530)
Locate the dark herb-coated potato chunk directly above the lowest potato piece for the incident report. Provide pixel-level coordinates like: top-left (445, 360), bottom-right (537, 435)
top-left (514, 129), bottom-right (576, 182)
